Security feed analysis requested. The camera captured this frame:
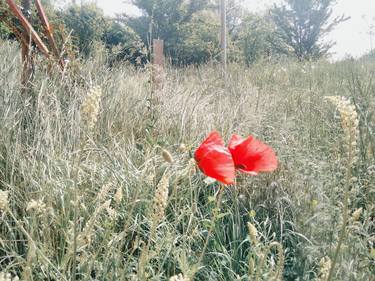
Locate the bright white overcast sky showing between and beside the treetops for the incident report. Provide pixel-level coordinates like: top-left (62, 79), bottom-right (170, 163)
top-left (96, 0), bottom-right (375, 59)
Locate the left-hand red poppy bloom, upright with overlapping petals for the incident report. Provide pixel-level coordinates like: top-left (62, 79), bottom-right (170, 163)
top-left (194, 132), bottom-right (235, 184)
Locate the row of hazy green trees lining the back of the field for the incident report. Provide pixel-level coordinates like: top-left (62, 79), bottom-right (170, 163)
top-left (0, 0), bottom-right (346, 65)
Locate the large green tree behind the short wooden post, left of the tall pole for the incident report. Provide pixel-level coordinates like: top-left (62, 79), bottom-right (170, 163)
top-left (125, 0), bottom-right (219, 64)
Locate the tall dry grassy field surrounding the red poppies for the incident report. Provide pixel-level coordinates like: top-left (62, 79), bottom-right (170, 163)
top-left (0, 42), bottom-right (375, 281)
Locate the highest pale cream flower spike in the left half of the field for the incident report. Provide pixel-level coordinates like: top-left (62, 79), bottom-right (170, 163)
top-left (81, 87), bottom-right (102, 129)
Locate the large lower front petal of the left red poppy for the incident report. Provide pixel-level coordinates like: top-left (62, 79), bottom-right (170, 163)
top-left (198, 145), bottom-right (235, 184)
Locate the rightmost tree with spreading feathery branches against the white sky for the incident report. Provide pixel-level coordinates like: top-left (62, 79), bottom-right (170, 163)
top-left (270, 0), bottom-right (349, 60)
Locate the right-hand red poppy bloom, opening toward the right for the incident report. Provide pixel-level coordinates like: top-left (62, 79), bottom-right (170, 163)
top-left (228, 135), bottom-right (277, 175)
